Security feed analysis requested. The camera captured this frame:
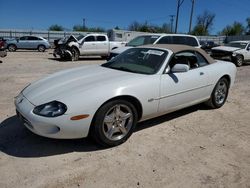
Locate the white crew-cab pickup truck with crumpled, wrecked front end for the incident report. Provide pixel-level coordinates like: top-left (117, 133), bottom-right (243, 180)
top-left (53, 34), bottom-right (126, 61)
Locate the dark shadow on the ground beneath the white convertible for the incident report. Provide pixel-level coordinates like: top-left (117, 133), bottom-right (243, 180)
top-left (0, 105), bottom-right (208, 158)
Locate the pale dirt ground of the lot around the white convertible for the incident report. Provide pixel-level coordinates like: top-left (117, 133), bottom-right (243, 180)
top-left (0, 51), bottom-right (250, 188)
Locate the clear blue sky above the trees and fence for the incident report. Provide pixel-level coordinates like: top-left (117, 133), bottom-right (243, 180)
top-left (0, 0), bottom-right (250, 34)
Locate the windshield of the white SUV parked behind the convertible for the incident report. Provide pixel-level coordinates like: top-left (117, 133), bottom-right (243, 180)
top-left (126, 35), bottom-right (160, 47)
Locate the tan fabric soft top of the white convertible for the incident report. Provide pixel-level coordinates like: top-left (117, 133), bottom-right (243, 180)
top-left (141, 44), bottom-right (215, 64)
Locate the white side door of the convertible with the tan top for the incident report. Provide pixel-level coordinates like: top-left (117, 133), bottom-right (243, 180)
top-left (159, 52), bottom-right (209, 113)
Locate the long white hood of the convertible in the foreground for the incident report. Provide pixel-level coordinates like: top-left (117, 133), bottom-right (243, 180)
top-left (22, 65), bottom-right (140, 106)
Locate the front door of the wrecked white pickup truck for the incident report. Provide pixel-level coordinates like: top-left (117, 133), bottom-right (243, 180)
top-left (80, 35), bottom-right (96, 55)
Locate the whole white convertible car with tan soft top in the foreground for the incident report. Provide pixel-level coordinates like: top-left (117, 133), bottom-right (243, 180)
top-left (15, 45), bottom-right (236, 146)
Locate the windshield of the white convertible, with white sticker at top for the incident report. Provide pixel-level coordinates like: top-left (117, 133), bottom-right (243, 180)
top-left (102, 48), bottom-right (168, 74)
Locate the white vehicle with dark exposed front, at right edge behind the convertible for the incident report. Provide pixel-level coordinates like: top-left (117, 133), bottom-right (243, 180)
top-left (211, 41), bottom-right (250, 67)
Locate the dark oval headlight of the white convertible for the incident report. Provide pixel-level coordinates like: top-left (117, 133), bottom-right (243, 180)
top-left (33, 101), bottom-right (67, 117)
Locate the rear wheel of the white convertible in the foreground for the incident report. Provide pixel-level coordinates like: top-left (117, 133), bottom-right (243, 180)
top-left (206, 78), bottom-right (229, 108)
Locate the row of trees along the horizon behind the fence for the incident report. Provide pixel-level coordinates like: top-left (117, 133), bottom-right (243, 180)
top-left (49, 10), bottom-right (250, 36)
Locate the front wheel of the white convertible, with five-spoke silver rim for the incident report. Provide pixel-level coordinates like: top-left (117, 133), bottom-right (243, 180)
top-left (91, 100), bottom-right (138, 146)
